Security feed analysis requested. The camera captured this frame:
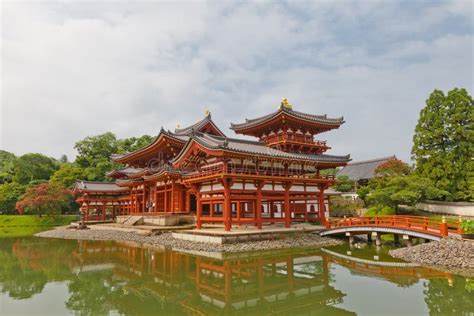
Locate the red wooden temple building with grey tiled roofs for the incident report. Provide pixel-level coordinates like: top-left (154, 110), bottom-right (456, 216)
top-left (75, 99), bottom-right (350, 230)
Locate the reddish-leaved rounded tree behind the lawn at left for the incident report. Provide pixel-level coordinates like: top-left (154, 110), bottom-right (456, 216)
top-left (16, 182), bottom-right (72, 217)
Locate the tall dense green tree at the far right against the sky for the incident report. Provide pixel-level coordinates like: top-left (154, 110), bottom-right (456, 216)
top-left (412, 88), bottom-right (474, 200)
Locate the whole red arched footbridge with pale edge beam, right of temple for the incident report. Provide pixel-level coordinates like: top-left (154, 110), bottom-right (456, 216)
top-left (320, 215), bottom-right (462, 242)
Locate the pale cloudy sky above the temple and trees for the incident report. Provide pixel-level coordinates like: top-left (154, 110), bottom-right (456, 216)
top-left (0, 0), bottom-right (474, 161)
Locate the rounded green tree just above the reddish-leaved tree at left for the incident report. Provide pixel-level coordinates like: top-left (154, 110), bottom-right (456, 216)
top-left (13, 154), bottom-right (58, 184)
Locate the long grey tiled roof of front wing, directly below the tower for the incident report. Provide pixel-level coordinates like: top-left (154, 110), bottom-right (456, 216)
top-left (175, 133), bottom-right (350, 163)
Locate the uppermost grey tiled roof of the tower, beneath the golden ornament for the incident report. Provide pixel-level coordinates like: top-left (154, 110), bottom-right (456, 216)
top-left (230, 107), bottom-right (344, 130)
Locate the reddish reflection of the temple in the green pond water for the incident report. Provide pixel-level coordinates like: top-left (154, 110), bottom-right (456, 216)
top-left (69, 242), bottom-right (352, 314)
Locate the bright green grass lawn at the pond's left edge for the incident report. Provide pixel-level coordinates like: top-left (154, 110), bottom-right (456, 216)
top-left (0, 215), bottom-right (78, 238)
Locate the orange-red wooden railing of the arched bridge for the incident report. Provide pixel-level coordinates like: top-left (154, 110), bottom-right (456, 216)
top-left (326, 215), bottom-right (462, 236)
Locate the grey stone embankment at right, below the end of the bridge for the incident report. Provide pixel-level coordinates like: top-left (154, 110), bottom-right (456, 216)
top-left (389, 238), bottom-right (474, 269)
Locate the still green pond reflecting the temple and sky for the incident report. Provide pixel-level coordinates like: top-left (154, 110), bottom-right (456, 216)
top-left (0, 237), bottom-right (474, 316)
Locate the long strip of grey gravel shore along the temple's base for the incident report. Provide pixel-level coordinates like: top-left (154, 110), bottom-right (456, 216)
top-left (35, 228), bottom-right (343, 252)
